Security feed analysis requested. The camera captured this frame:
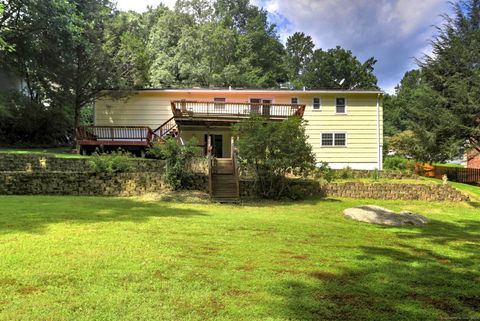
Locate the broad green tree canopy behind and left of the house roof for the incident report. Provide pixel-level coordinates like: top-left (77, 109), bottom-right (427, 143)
top-left (0, 0), bottom-right (376, 144)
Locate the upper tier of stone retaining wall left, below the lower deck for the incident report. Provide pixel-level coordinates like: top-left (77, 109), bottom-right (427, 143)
top-left (0, 153), bottom-right (165, 172)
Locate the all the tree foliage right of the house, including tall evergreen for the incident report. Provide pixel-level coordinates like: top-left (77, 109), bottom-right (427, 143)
top-left (385, 0), bottom-right (480, 162)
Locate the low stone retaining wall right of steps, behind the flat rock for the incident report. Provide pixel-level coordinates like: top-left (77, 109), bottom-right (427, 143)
top-left (240, 180), bottom-right (468, 202)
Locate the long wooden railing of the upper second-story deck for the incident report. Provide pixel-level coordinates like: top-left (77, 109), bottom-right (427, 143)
top-left (171, 100), bottom-right (305, 119)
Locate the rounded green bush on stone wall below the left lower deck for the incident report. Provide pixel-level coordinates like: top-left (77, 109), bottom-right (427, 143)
top-left (89, 149), bottom-right (133, 174)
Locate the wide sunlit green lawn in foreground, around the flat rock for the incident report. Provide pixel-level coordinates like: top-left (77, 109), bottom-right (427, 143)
top-left (0, 196), bottom-right (480, 321)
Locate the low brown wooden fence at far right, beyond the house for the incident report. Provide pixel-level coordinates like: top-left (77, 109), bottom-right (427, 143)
top-left (417, 164), bottom-right (480, 185)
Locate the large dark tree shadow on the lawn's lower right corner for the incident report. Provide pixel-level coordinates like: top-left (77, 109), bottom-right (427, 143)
top-left (276, 216), bottom-right (480, 321)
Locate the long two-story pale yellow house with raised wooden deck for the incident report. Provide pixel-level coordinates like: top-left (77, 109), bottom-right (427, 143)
top-left (79, 89), bottom-right (383, 169)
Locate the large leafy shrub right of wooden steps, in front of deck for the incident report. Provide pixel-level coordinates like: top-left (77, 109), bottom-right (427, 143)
top-left (234, 116), bottom-right (315, 199)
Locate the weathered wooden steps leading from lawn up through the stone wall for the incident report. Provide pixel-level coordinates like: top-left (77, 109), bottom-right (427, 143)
top-left (210, 158), bottom-right (240, 203)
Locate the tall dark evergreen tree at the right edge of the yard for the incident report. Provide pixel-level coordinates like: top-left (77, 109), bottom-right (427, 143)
top-left (420, 0), bottom-right (480, 151)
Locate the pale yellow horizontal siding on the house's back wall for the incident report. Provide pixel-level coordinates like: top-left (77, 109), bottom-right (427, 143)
top-left (95, 91), bottom-right (383, 168)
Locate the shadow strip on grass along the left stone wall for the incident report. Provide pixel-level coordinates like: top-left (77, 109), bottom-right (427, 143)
top-left (0, 196), bottom-right (207, 233)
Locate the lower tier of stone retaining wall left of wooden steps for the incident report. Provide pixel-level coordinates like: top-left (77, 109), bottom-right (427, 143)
top-left (0, 172), bottom-right (208, 196)
